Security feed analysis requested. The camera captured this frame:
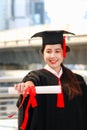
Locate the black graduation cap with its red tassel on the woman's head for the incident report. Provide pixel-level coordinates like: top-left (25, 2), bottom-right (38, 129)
top-left (31, 30), bottom-right (74, 57)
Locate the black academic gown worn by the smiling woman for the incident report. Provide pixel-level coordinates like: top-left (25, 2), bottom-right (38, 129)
top-left (17, 69), bottom-right (87, 130)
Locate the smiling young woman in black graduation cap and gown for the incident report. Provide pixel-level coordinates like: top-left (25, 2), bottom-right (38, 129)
top-left (15, 31), bottom-right (87, 130)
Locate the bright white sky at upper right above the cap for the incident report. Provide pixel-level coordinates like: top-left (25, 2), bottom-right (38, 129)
top-left (45, 0), bottom-right (87, 33)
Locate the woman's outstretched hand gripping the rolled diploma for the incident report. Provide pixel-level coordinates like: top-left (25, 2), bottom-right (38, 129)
top-left (14, 81), bottom-right (35, 94)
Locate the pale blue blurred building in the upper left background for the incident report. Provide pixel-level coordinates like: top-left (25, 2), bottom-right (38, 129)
top-left (0, 0), bottom-right (50, 30)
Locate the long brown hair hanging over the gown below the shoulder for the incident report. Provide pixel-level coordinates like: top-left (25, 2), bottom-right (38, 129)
top-left (62, 64), bottom-right (82, 99)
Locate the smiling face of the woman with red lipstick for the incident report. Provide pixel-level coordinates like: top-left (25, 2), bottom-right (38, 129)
top-left (43, 44), bottom-right (63, 72)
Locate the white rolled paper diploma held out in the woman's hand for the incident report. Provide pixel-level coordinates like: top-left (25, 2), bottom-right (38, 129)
top-left (8, 85), bottom-right (61, 94)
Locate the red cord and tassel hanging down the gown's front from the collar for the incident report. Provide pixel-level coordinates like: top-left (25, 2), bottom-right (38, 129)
top-left (57, 78), bottom-right (64, 108)
